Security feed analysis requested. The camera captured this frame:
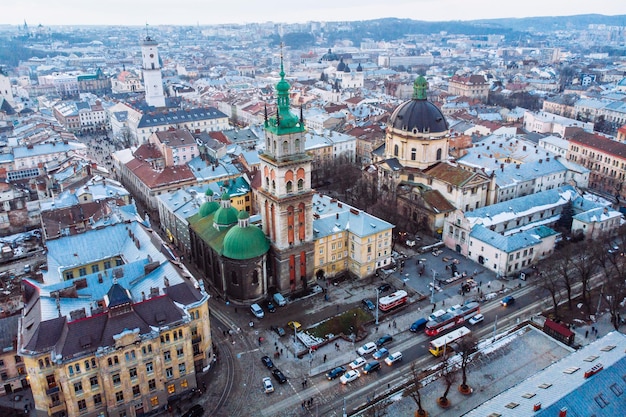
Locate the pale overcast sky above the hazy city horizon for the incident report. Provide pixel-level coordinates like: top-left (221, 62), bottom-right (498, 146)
top-left (0, 0), bottom-right (626, 26)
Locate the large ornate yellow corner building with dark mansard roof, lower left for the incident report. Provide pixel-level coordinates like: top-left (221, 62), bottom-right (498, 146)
top-left (18, 222), bottom-right (213, 417)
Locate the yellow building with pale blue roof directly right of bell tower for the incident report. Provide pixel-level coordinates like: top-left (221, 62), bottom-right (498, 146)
top-left (313, 194), bottom-right (394, 279)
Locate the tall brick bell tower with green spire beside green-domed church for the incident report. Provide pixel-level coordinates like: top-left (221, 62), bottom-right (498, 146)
top-left (258, 48), bottom-right (314, 292)
